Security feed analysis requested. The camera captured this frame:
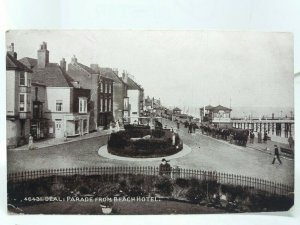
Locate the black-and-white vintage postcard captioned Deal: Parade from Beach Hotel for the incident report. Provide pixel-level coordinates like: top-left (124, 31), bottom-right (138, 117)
top-left (6, 30), bottom-right (295, 215)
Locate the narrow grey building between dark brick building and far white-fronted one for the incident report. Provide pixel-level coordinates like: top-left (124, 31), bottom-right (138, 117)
top-left (91, 64), bottom-right (128, 123)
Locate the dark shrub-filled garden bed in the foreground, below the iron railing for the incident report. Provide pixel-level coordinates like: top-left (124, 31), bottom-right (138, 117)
top-left (8, 174), bottom-right (294, 214)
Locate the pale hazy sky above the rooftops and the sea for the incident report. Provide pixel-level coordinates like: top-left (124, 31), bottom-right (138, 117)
top-left (6, 30), bottom-right (294, 112)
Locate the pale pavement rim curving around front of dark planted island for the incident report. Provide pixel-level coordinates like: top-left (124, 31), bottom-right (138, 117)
top-left (98, 144), bottom-right (192, 162)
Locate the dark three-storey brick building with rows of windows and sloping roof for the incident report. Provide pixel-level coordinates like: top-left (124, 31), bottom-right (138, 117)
top-left (68, 56), bottom-right (114, 131)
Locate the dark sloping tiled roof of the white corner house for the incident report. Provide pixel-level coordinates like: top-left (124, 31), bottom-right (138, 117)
top-left (32, 63), bottom-right (74, 87)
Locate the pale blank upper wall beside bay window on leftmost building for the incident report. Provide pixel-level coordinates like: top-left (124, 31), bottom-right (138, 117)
top-left (6, 70), bottom-right (19, 116)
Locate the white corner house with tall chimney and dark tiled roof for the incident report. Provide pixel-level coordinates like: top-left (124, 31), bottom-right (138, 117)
top-left (22, 42), bottom-right (90, 138)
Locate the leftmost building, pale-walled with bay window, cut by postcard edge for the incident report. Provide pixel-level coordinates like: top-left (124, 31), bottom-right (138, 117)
top-left (6, 43), bottom-right (32, 148)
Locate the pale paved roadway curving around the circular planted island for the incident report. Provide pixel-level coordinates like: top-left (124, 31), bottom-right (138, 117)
top-left (7, 120), bottom-right (294, 185)
